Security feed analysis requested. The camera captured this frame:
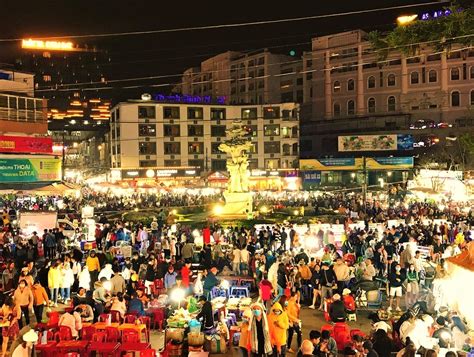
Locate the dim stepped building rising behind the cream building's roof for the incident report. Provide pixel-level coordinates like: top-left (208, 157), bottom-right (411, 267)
top-left (175, 50), bottom-right (303, 104)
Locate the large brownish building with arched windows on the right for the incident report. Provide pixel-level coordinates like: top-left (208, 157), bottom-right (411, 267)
top-left (301, 30), bottom-right (474, 157)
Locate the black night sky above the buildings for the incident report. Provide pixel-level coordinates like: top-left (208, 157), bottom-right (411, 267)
top-left (0, 0), bottom-right (458, 97)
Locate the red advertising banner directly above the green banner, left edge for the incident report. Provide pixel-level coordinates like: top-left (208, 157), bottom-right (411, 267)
top-left (0, 135), bottom-right (53, 154)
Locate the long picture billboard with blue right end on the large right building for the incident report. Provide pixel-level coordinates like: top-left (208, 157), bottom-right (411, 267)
top-left (337, 134), bottom-right (413, 152)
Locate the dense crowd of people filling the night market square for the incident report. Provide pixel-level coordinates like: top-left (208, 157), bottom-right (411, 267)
top-left (0, 189), bottom-right (473, 357)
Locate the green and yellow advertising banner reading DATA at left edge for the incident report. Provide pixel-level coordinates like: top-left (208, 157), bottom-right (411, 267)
top-left (0, 157), bottom-right (61, 183)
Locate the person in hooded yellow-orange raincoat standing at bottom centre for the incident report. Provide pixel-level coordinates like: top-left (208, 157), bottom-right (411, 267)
top-left (268, 302), bottom-right (290, 357)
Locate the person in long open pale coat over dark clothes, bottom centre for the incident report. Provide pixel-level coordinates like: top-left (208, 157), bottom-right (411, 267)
top-left (249, 303), bottom-right (273, 357)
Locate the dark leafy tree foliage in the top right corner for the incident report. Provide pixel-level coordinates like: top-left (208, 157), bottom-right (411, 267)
top-left (369, 5), bottom-right (474, 59)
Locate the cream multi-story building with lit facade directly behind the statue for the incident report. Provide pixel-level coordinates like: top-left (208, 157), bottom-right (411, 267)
top-left (109, 100), bottom-right (299, 189)
